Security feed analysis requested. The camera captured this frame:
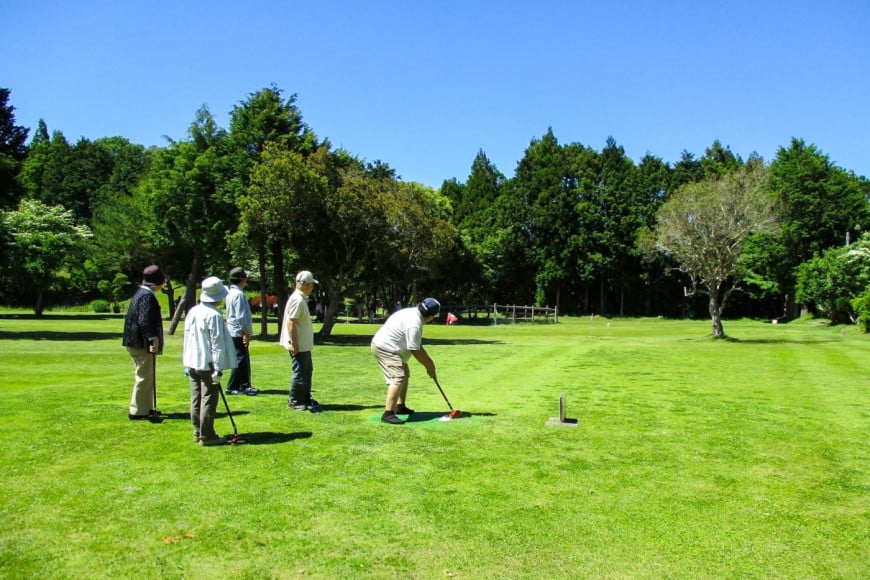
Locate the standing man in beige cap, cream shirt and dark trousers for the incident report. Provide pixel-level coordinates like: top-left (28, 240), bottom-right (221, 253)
top-left (280, 270), bottom-right (320, 412)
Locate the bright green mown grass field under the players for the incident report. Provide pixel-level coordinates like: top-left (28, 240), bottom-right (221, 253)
top-left (0, 311), bottom-right (870, 578)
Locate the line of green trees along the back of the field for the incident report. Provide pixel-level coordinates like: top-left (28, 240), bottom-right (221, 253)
top-left (0, 86), bottom-right (870, 335)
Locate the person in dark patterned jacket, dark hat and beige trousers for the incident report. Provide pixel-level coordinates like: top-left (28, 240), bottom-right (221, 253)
top-left (122, 265), bottom-right (167, 423)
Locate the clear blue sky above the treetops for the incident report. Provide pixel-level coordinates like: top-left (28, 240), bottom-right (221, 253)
top-left (0, 0), bottom-right (870, 187)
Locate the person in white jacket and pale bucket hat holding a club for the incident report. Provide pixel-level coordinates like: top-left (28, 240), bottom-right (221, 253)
top-left (182, 276), bottom-right (238, 446)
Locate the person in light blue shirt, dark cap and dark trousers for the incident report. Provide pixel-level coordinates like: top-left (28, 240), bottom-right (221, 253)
top-left (226, 268), bottom-right (259, 396)
